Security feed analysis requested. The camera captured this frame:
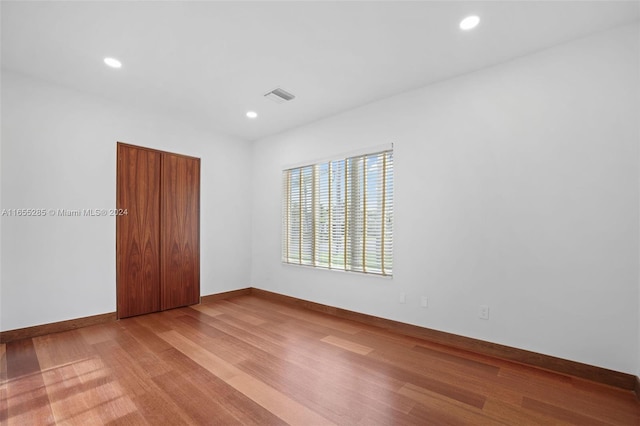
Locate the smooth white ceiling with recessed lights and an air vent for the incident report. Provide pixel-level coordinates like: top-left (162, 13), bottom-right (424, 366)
top-left (1, 1), bottom-right (640, 140)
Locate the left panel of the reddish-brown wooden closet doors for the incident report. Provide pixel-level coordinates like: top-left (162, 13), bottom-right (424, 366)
top-left (116, 143), bottom-right (161, 318)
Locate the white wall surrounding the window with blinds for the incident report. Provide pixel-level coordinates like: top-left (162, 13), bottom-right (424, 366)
top-left (252, 26), bottom-right (640, 374)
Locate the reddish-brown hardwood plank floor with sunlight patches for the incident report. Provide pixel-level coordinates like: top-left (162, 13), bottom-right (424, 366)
top-left (0, 296), bottom-right (640, 425)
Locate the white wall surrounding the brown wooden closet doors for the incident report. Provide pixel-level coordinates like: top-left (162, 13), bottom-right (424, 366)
top-left (0, 71), bottom-right (251, 330)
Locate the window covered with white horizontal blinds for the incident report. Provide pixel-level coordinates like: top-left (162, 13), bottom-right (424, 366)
top-left (282, 150), bottom-right (393, 275)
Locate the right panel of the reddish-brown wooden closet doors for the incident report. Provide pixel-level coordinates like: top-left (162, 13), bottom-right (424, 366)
top-left (160, 153), bottom-right (200, 310)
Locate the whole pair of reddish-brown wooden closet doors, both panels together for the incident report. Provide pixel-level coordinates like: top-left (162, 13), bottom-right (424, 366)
top-left (116, 143), bottom-right (200, 318)
